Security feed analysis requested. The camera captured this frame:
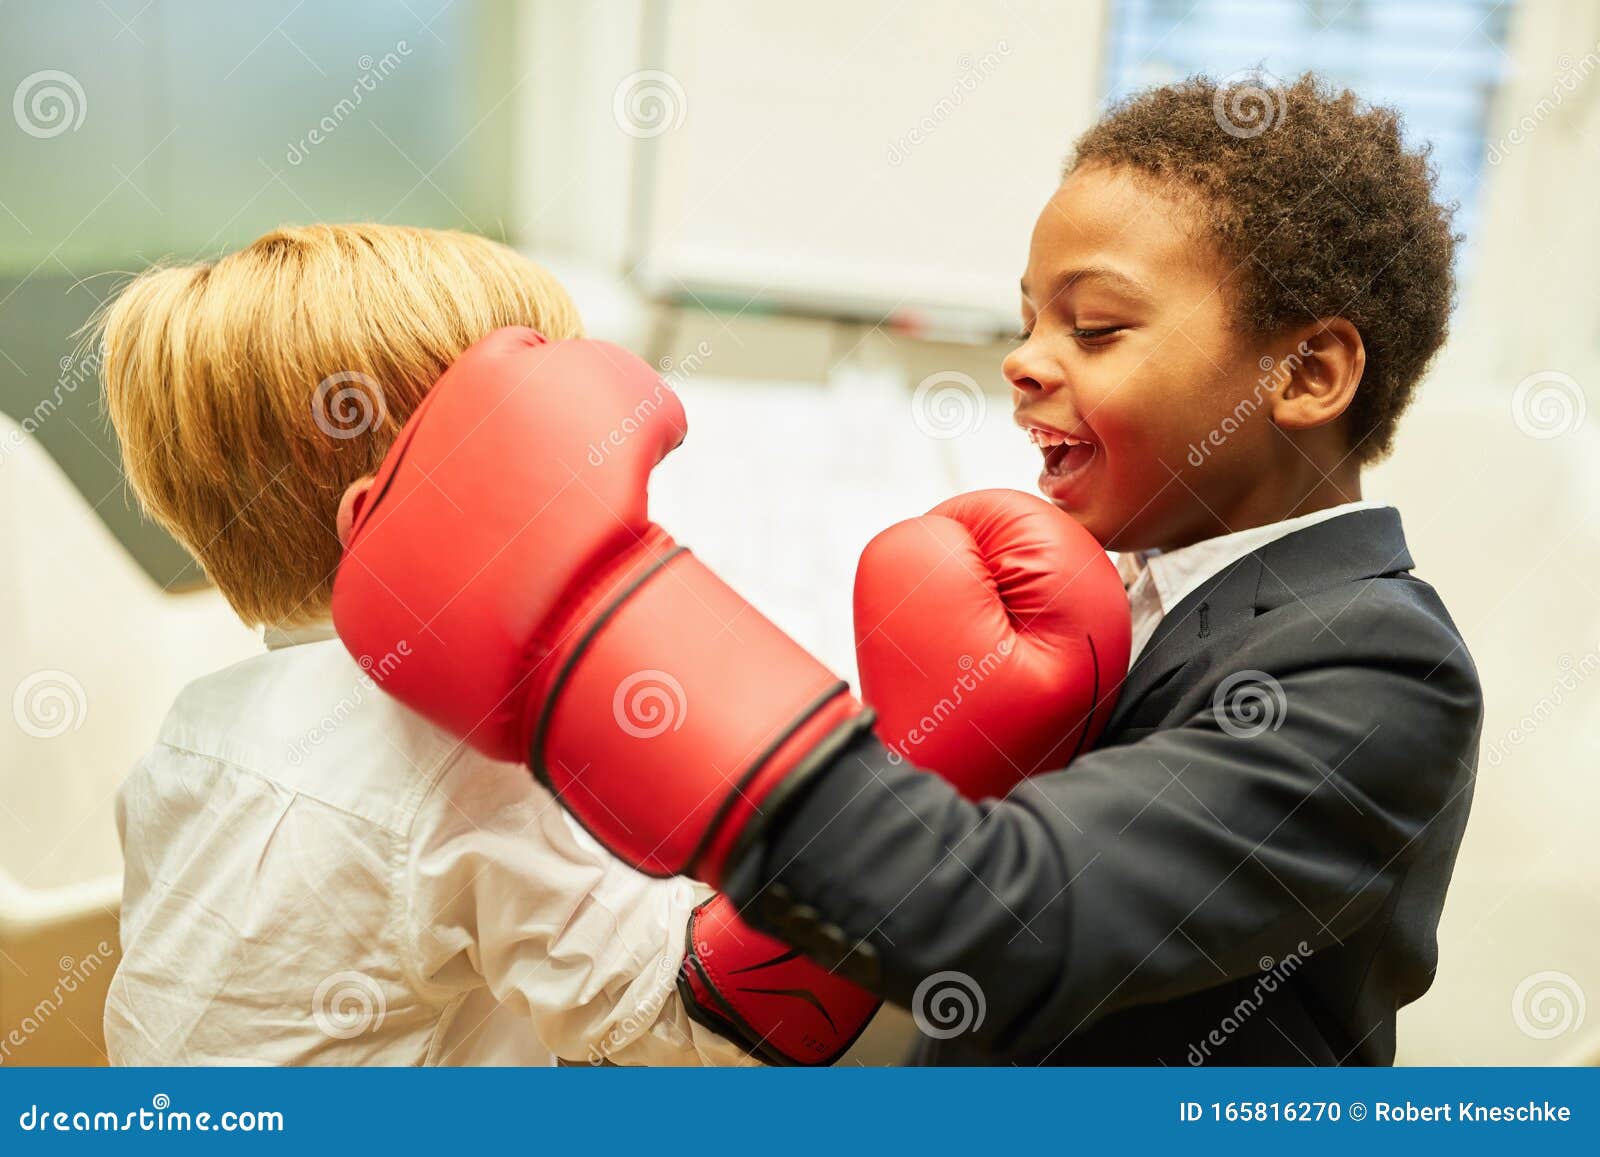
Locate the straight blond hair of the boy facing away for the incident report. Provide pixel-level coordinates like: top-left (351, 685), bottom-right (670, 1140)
top-left (98, 224), bottom-right (582, 624)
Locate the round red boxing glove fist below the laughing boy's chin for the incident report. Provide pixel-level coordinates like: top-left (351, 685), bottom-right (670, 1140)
top-left (856, 490), bottom-right (1131, 800)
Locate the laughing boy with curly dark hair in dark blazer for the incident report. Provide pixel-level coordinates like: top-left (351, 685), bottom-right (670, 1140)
top-left (726, 75), bottom-right (1483, 1066)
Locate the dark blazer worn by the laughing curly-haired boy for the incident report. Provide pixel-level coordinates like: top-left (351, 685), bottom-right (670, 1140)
top-left (728, 507), bottom-right (1483, 1064)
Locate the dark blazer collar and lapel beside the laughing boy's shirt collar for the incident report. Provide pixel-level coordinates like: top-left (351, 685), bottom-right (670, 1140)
top-left (1101, 506), bottom-right (1413, 746)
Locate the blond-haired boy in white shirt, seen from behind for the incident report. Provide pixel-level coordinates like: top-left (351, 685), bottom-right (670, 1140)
top-left (102, 224), bottom-right (744, 1064)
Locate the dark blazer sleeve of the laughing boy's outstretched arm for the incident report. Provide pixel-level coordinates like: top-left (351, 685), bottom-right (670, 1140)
top-left (728, 592), bottom-right (1482, 1051)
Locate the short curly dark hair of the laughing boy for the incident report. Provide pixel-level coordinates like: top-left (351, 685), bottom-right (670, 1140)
top-left (1066, 72), bottom-right (1459, 462)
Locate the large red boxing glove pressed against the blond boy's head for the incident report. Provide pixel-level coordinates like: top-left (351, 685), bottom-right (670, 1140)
top-left (333, 328), bottom-right (872, 885)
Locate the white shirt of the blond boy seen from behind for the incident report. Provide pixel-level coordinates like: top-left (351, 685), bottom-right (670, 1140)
top-left (106, 626), bottom-right (746, 1064)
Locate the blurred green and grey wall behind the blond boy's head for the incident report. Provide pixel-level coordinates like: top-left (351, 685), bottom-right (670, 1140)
top-left (0, 0), bottom-right (518, 586)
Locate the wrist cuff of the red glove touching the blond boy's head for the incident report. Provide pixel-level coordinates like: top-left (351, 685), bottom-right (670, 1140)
top-left (528, 534), bottom-right (870, 885)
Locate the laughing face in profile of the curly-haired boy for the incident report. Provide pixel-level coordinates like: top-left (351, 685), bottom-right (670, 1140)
top-left (1005, 166), bottom-right (1298, 550)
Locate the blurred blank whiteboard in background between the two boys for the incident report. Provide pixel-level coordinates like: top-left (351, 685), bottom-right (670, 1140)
top-left (630, 0), bottom-right (1104, 330)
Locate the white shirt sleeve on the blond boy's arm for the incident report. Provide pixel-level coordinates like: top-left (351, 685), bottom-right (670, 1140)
top-left (402, 751), bottom-right (750, 1066)
